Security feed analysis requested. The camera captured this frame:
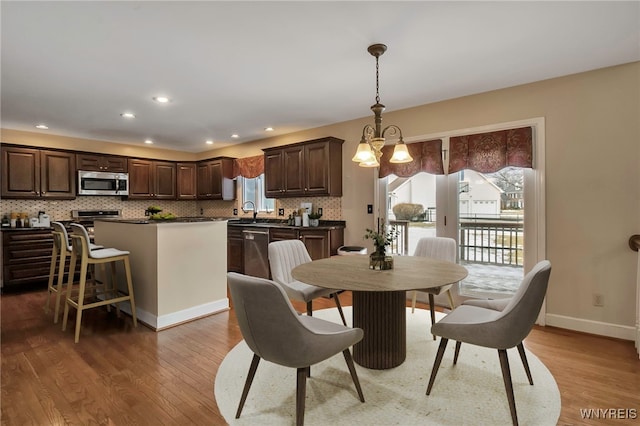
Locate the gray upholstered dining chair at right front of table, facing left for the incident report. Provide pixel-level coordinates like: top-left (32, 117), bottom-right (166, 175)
top-left (427, 260), bottom-right (551, 425)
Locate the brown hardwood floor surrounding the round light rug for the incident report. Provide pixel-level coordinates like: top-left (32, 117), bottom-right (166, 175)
top-left (0, 291), bottom-right (640, 426)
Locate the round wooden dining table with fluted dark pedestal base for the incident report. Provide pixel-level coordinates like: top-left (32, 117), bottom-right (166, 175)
top-left (291, 255), bottom-right (467, 370)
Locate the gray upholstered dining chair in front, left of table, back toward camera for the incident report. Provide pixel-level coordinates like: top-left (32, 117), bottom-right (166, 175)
top-left (227, 272), bottom-right (364, 425)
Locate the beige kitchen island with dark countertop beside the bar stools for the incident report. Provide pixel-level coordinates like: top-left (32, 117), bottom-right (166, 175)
top-left (94, 218), bottom-right (229, 331)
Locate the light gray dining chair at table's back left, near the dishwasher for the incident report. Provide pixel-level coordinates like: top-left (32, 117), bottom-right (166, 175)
top-left (268, 240), bottom-right (347, 325)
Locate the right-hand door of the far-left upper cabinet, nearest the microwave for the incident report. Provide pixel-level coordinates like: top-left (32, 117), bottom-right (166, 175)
top-left (40, 150), bottom-right (76, 199)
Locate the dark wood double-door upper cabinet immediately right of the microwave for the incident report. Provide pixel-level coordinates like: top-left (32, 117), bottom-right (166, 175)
top-left (128, 159), bottom-right (176, 200)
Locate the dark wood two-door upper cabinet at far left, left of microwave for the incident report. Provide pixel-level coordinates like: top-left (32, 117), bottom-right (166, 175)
top-left (0, 145), bottom-right (76, 199)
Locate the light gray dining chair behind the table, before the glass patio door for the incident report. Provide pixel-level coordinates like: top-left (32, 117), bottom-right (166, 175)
top-left (411, 237), bottom-right (458, 340)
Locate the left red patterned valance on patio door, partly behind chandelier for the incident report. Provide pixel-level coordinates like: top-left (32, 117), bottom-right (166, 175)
top-left (378, 139), bottom-right (444, 178)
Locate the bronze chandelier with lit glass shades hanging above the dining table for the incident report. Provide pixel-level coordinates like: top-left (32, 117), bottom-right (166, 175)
top-left (352, 44), bottom-right (413, 167)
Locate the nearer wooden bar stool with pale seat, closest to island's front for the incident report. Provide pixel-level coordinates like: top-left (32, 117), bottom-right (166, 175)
top-left (62, 223), bottom-right (138, 343)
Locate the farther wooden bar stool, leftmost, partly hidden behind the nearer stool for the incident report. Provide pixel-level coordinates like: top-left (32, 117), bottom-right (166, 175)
top-left (44, 222), bottom-right (103, 324)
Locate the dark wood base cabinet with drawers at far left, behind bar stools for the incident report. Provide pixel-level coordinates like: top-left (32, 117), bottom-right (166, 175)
top-left (2, 229), bottom-right (53, 290)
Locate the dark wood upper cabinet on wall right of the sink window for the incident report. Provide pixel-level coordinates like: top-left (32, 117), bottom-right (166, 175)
top-left (263, 137), bottom-right (344, 198)
